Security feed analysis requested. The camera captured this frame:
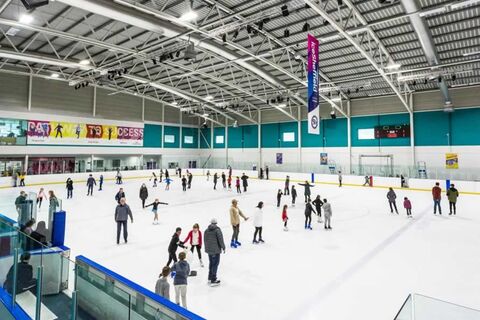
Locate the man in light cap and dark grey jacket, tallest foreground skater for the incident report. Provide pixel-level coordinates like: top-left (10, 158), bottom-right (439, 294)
top-left (203, 218), bottom-right (225, 286)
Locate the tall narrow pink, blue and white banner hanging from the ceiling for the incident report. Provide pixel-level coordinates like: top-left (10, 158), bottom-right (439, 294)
top-left (307, 34), bottom-right (320, 134)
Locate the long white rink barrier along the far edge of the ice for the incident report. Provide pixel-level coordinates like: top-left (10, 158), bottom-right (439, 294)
top-left (0, 168), bottom-right (480, 195)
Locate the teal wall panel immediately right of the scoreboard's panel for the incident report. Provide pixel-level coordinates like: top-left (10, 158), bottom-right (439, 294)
top-left (413, 111), bottom-right (450, 147)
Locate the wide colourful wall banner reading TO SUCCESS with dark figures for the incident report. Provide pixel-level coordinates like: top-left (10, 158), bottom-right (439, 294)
top-left (27, 120), bottom-right (143, 147)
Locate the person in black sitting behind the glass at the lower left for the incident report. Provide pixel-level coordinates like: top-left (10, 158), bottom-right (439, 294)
top-left (3, 252), bottom-right (37, 294)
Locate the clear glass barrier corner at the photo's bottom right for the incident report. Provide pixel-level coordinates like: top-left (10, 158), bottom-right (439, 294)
top-left (394, 293), bottom-right (480, 320)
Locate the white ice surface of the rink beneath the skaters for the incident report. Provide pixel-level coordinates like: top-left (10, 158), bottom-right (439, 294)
top-left (0, 172), bottom-right (480, 320)
